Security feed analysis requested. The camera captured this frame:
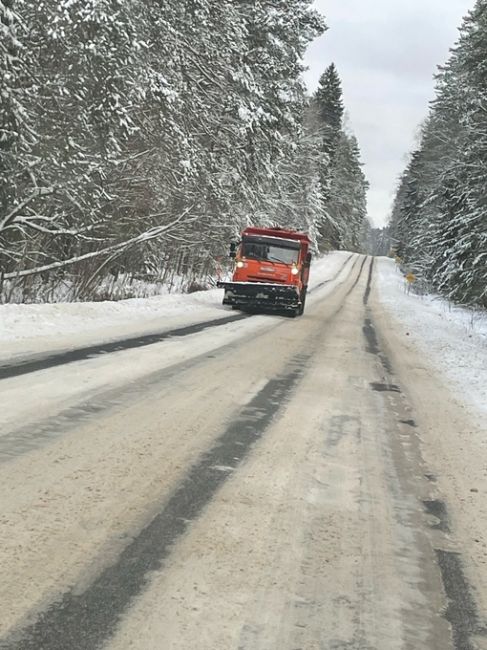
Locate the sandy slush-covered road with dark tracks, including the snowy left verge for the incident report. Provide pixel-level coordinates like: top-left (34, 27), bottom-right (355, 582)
top-left (0, 254), bottom-right (487, 650)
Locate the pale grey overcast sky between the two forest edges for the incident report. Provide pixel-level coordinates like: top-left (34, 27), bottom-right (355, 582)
top-left (306, 0), bottom-right (474, 226)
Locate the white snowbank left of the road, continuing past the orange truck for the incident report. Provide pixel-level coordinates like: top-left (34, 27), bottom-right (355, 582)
top-left (0, 251), bottom-right (350, 358)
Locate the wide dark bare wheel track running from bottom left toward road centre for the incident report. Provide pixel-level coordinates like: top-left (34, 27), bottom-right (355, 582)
top-left (0, 354), bottom-right (310, 650)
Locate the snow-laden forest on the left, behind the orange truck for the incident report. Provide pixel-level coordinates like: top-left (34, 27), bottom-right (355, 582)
top-left (0, 0), bottom-right (366, 302)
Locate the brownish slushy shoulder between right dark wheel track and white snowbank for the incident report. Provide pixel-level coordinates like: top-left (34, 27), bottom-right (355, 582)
top-left (371, 286), bottom-right (487, 624)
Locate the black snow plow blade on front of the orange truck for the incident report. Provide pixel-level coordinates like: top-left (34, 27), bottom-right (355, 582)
top-left (217, 282), bottom-right (300, 310)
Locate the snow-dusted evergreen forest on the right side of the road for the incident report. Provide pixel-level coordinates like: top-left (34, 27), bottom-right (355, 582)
top-left (390, 0), bottom-right (487, 308)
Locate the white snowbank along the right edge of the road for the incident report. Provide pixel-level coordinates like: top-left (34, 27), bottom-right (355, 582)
top-left (377, 258), bottom-right (487, 417)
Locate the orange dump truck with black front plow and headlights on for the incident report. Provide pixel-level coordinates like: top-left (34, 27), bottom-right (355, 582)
top-left (217, 228), bottom-right (311, 316)
